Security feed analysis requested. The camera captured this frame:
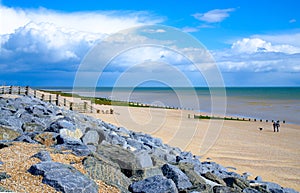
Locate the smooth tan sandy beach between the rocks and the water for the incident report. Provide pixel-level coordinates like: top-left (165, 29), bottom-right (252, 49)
top-left (89, 105), bottom-right (300, 191)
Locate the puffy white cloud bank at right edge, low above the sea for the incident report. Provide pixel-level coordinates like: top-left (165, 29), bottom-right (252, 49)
top-left (213, 33), bottom-right (300, 73)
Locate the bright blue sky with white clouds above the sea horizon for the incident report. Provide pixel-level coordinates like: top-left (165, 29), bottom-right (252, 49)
top-left (0, 0), bottom-right (300, 86)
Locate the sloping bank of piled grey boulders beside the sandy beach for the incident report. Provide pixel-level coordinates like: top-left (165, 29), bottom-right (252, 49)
top-left (0, 96), bottom-right (297, 193)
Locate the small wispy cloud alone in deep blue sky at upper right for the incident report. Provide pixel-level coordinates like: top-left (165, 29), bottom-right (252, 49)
top-left (192, 8), bottom-right (235, 23)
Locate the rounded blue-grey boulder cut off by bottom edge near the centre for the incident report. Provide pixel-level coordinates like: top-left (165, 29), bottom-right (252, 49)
top-left (129, 175), bottom-right (178, 193)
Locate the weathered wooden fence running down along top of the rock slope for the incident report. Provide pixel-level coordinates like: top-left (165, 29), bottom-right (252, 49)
top-left (0, 86), bottom-right (113, 114)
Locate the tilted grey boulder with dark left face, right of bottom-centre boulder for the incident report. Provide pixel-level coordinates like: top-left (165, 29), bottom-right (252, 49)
top-left (161, 164), bottom-right (193, 191)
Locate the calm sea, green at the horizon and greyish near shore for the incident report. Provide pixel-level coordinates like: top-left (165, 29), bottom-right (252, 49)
top-left (39, 87), bottom-right (300, 125)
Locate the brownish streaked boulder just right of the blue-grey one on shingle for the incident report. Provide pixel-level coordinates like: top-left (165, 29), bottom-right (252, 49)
top-left (82, 154), bottom-right (131, 192)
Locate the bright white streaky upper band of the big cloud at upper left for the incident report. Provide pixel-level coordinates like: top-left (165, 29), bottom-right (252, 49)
top-left (0, 6), bottom-right (162, 34)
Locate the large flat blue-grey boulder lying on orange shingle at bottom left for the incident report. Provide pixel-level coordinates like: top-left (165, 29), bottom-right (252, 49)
top-left (28, 162), bottom-right (98, 193)
